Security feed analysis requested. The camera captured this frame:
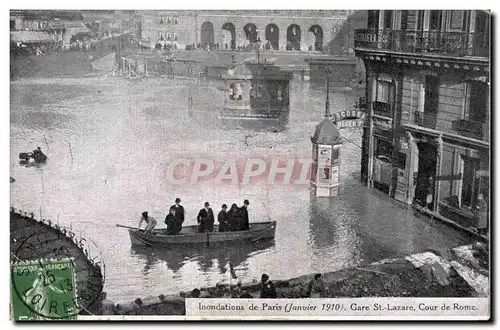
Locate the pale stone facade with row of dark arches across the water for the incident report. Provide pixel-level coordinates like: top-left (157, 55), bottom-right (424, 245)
top-left (140, 10), bottom-right (350, 51)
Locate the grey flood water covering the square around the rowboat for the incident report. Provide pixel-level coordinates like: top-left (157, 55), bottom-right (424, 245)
top-left (10, 77), bottom-right (466, 302)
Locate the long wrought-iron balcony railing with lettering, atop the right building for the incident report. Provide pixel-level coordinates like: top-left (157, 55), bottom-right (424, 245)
top-left (354, 29), bottom-right (490, 57)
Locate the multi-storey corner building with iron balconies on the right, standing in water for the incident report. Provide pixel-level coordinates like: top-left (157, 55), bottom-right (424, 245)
top-left (355, 10), bottom-right (491, 232)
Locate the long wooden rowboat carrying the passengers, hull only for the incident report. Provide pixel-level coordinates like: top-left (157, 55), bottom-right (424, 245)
top-left (116, 221), bottom-right (276, 246)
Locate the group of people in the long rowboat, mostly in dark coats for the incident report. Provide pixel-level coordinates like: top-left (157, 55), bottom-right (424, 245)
top-left (138, 198), bottom-right (250, 235)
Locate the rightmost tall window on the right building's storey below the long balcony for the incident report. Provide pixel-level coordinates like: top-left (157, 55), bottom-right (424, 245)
top-left (463, 81), bottom-right (488, 123)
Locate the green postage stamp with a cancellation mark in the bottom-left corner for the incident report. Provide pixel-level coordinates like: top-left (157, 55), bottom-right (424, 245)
top-left (11, 259), bottom-right (78, 321)
